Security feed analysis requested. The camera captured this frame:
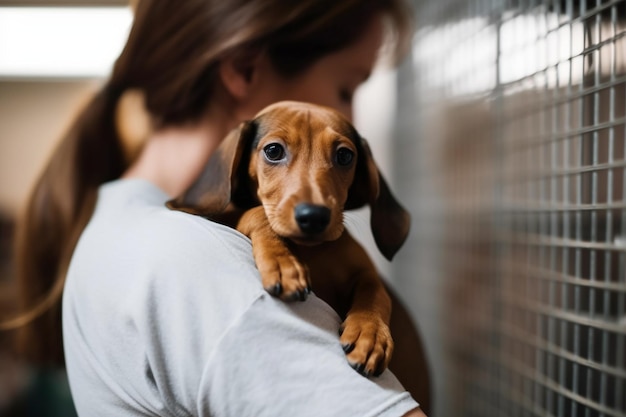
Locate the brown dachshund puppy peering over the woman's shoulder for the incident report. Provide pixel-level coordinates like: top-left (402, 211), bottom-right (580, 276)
top-left (168, 102), bottom-right (410, 376)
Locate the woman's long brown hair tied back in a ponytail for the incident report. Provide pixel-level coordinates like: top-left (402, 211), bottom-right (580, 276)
top-left (6, 0), bottom-right (411, 364)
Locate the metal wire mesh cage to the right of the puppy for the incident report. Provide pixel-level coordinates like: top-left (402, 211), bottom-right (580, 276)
top-left (394, 0), bottom-right (626, 417)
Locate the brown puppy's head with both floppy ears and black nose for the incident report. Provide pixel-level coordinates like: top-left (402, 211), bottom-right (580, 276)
top-left (168, 102), bottom-right (410, 259)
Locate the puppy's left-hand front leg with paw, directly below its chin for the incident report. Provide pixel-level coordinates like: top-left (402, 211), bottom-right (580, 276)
top-left (237, 206), bottom-right (311, 301)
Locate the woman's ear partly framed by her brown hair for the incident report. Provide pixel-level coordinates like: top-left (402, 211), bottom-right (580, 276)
top-left (219, 50), bottom-right (262, 100)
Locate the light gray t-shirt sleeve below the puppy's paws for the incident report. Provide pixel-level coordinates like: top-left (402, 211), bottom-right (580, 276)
top-left (198, 294), bottom-right (418, 417)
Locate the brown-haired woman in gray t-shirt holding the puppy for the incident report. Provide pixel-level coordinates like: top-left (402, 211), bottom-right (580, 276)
top-left (14, 0), bottom-right (423, 416)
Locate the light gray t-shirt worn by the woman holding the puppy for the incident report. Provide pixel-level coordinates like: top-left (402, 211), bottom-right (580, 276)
top-left (63, 180), bottom-right (417, 417)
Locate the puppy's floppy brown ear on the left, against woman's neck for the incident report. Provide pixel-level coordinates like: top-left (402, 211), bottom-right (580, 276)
top-left (166, 121), bottom-right (256, 217)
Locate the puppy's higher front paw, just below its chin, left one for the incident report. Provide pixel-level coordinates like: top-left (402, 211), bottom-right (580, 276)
top-left (257, 253), bottom-right (311, 301)
